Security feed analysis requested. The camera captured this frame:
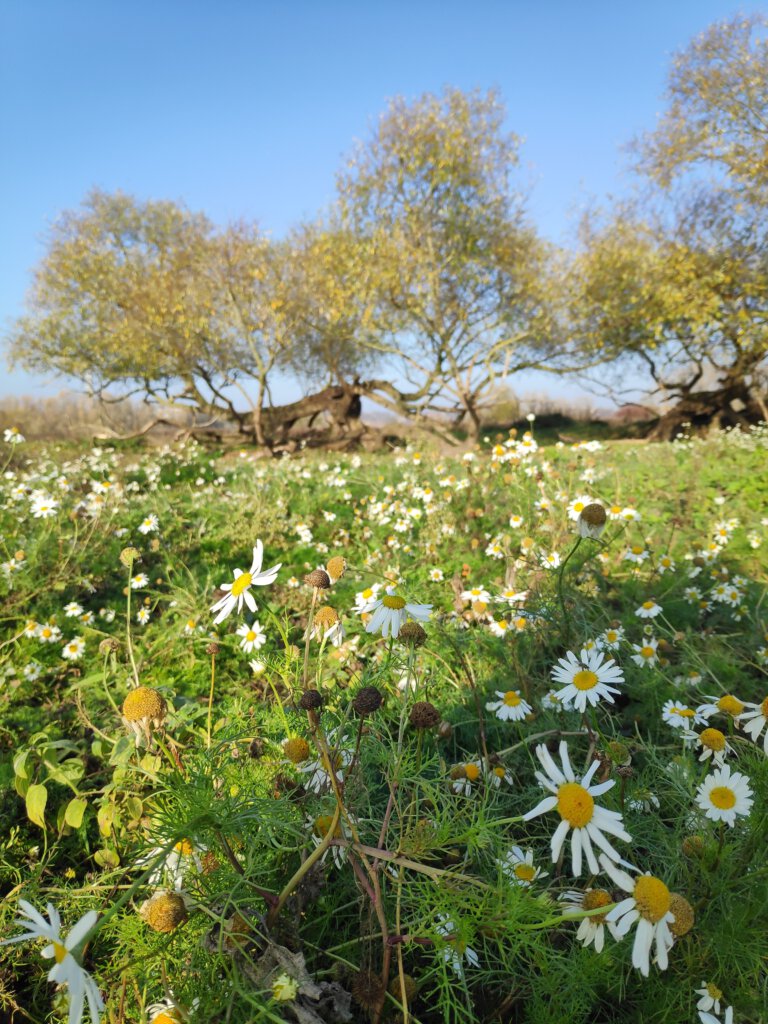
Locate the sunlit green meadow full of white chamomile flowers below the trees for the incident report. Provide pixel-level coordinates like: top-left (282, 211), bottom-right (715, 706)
top-left (0, 423), bottom-right (768, 1024)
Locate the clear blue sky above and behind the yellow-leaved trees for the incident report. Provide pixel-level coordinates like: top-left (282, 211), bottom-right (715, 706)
top-left (0, 0), bottom-right (758, 397)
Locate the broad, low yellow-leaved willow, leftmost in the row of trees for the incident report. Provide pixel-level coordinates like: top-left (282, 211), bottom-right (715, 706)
top-left (11, 191), bottom-right (339, 442)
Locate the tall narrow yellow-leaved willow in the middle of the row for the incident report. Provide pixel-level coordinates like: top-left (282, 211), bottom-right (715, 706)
top-left (339, 89), bottom-right (569, 434)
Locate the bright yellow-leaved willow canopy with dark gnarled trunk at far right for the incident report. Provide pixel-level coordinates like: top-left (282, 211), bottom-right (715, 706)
top-left (571, 193), bottom-right (768, 437)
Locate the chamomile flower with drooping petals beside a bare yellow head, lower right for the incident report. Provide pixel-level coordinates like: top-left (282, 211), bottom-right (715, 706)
top-left (600, 853), bottom-right (675, 978)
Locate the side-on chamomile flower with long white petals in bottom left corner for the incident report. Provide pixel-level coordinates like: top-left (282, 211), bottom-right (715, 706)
top-left (0, 899), bottom-right (104, 1024)
